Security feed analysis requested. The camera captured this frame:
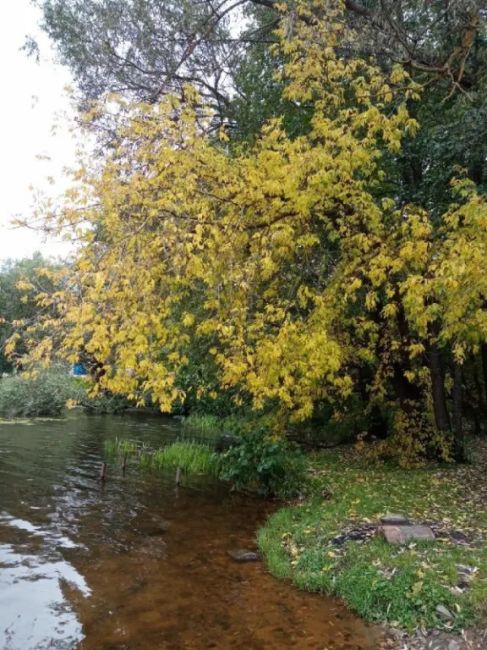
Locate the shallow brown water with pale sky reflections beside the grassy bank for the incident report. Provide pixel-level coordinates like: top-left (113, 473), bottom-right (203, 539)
top-left (0, 415), bottom-right (379, 650)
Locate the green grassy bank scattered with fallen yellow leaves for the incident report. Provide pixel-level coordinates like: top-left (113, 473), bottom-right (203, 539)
top-left (259, 442), bottom-right (487, 630)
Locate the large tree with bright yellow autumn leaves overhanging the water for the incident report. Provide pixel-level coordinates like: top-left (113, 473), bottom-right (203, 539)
top-left (23, 1), bottom-right (487, 462)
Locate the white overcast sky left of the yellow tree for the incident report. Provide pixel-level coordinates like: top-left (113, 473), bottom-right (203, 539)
top-left (0, 0), bottom-right (74, 263)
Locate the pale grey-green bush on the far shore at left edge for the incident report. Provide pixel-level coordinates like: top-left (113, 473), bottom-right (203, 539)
top-left (0, 367), bottom-right (79, 418)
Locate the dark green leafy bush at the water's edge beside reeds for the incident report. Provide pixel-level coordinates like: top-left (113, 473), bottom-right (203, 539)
top-left (221, 429), bottom-right (306, 497)
